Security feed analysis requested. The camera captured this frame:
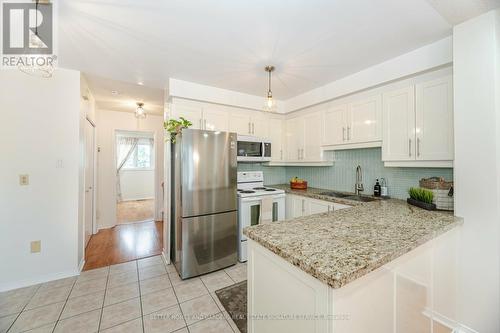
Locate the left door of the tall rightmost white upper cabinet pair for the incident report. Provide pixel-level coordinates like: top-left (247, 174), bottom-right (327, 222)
top-left (382, 86), bottom-right (416, 161)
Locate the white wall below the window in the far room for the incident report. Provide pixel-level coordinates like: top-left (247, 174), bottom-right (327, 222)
top-left (120, 169), bottom-right (155, 201)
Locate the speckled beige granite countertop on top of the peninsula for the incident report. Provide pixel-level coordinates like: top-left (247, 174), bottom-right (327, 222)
top-left (244, 199), bottom-right (462, 288)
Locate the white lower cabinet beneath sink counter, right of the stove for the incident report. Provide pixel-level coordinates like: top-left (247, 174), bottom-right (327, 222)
top-left (286, 194), bottom-right (351, 219)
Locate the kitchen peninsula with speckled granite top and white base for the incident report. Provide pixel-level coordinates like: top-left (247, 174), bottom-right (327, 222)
top-left (245, 199), bottom-right (461, 333)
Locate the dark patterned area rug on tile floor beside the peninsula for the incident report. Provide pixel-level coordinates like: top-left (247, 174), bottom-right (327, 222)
top-left (215, 281), bottom-right (247, 333)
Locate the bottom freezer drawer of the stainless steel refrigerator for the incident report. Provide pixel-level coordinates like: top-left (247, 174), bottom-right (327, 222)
top-left (176, 211), bottom-right (238, 279)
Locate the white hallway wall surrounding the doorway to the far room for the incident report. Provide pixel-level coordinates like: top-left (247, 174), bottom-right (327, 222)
top-left (97, 109), bottom-right (165, 229)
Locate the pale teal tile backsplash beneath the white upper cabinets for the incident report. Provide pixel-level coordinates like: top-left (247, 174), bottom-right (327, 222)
top-left (238, 148), bottom-right (453, 199)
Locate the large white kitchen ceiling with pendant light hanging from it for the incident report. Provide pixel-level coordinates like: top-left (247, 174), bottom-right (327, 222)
top-left (58, 0), bottom-right (496, 99)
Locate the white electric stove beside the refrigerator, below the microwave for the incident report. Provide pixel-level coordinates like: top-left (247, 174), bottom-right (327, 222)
top-left (237, 171), bottom-right (285, 262)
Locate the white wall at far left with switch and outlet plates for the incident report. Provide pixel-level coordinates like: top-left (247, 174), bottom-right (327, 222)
top-left (0, 69), bottom-right (81, 291)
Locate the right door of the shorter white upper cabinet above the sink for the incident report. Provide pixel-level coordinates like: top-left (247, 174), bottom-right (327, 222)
top-left (347, 95), bottom-right (382, 143)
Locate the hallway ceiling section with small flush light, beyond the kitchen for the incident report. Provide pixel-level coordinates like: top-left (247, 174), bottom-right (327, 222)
top-left (85, 74), bottom-right (164, 115)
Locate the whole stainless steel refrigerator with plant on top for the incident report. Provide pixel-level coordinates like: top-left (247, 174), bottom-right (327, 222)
top-left (170, 129), bottom-right (238, 279)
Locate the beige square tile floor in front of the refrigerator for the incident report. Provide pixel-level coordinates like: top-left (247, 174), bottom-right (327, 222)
top-left (0, 256), bottom-right (246, 333)
